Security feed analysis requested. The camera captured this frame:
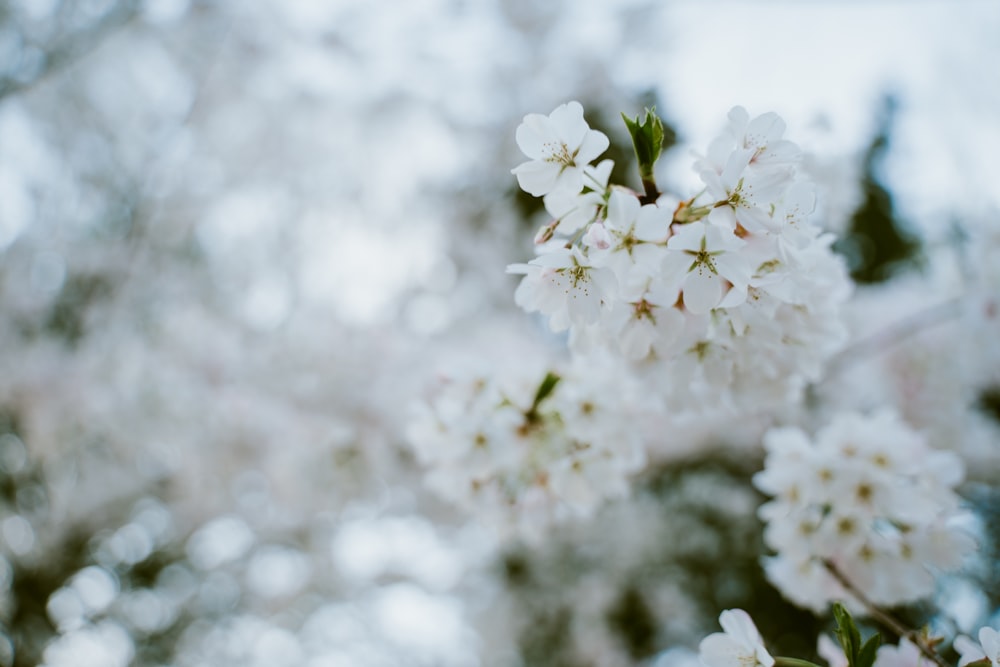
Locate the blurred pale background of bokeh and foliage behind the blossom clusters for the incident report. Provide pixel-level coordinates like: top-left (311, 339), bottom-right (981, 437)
top-left (0, 0), bottom-right (1000, 667)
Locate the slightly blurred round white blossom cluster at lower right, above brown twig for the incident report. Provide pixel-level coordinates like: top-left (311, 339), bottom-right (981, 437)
top-left (754, 412), bottom-right (974, 612)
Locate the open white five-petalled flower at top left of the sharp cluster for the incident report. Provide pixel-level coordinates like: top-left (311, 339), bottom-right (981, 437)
top-left (511, 102), bottom-right (609, 197)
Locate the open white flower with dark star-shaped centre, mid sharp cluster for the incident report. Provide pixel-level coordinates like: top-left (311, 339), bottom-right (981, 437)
top-left (663, 222), bottom-right (750, 313)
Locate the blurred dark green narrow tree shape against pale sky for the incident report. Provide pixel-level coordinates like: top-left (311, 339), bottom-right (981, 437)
top-left (834, 96), bottom-right (920, 283)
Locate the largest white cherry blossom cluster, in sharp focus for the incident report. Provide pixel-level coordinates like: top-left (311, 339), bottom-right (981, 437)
top-left (508, 102), bottom-right (850, 409)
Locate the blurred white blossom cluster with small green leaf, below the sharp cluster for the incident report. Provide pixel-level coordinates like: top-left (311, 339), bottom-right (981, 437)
top-left (408, 366), bottom-right (645, 534)
